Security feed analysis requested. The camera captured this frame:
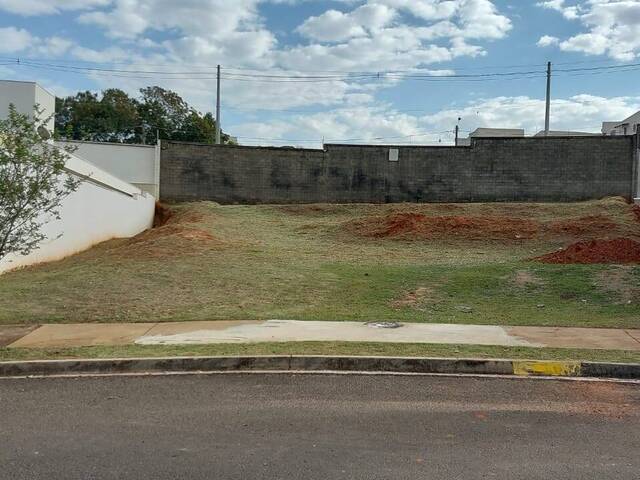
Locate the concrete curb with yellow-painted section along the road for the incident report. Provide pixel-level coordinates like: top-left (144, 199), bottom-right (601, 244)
top-left (0, 355), bottom-right (640, 379)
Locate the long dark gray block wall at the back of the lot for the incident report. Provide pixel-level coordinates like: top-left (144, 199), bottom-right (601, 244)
top-left (160, 137), bottom-right (635, 203)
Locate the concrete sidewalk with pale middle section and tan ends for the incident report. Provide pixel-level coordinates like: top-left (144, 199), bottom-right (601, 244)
top-left (5, 320), bottom-right (640, 351)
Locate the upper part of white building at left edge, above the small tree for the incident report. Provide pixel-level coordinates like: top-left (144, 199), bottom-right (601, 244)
top-left (0, 80), bottom-right (56, 133)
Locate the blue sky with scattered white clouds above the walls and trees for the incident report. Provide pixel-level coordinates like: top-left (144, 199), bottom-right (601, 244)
top-left (0, 0), bottom-right (640, 148)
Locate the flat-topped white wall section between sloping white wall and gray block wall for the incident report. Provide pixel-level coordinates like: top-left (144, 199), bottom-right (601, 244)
top-left (56, 141), bottom-right (160, 198)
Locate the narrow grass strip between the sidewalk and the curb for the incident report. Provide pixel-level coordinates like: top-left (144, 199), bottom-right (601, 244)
top-left (0, 342), bottom-right (640, 363)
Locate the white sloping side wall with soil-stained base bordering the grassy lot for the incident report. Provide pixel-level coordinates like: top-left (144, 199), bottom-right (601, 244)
top-left (0, 148), bottom-right (155, 273)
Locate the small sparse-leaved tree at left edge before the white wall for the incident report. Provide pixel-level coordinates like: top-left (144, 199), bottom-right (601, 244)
top-left (0, 105), bottom-right (80, 259)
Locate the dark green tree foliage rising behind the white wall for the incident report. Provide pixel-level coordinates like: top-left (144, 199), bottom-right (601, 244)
top-left (56, 86), bottom-right (232, 144)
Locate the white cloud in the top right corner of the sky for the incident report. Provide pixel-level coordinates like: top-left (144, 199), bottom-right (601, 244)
top-left (539, 0), bottom-right (640, 61)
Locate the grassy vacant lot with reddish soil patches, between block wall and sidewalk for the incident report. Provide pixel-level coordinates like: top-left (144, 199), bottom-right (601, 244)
top-left (0, 199), bottom-right (640, 328)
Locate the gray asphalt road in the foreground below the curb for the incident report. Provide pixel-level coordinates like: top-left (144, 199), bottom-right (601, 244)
top-left (0, 374), bottom-right (640, 480)
